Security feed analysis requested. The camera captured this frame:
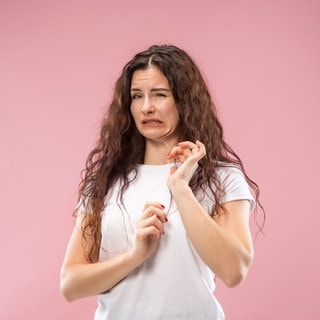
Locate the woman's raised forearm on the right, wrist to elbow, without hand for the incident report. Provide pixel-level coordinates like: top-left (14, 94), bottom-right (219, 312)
top-left (170, 183), bottom-right (253, 287)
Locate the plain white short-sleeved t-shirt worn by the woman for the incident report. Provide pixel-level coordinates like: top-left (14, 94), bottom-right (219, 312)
top-left (95, 164), bottom-right (254, 320)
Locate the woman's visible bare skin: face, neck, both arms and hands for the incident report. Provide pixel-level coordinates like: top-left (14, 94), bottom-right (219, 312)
top-left (60, 67), bottom-right (253, 301)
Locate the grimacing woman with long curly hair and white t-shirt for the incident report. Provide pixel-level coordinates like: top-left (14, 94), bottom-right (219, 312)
top-left (61, 45), bottom-right (259, 320)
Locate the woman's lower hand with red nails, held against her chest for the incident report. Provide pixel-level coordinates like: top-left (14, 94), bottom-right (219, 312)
top-left (132, 202), bottom-right (168, 263)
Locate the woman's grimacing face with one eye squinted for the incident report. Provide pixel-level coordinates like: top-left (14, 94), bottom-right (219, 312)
top-left (130, 66), bottom-right (179, 142)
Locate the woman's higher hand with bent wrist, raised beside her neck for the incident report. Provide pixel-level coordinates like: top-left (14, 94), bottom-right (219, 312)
top-left (167, 140), bottom-right (206, 188)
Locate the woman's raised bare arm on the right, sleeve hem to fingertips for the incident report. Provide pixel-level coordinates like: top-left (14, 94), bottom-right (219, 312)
top-left (168, 142), bottom-right (253, 287)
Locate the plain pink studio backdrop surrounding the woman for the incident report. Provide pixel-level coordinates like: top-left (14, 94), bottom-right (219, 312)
top-left (0, 0), bottom-right (320, 320)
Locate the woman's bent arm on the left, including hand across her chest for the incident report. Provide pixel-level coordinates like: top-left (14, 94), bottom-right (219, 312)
top-left (60, 202), bottom-right (166, 301)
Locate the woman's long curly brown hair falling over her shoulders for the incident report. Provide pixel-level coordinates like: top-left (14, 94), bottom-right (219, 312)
top-left (79, 45), bottom-right (264, 262)
